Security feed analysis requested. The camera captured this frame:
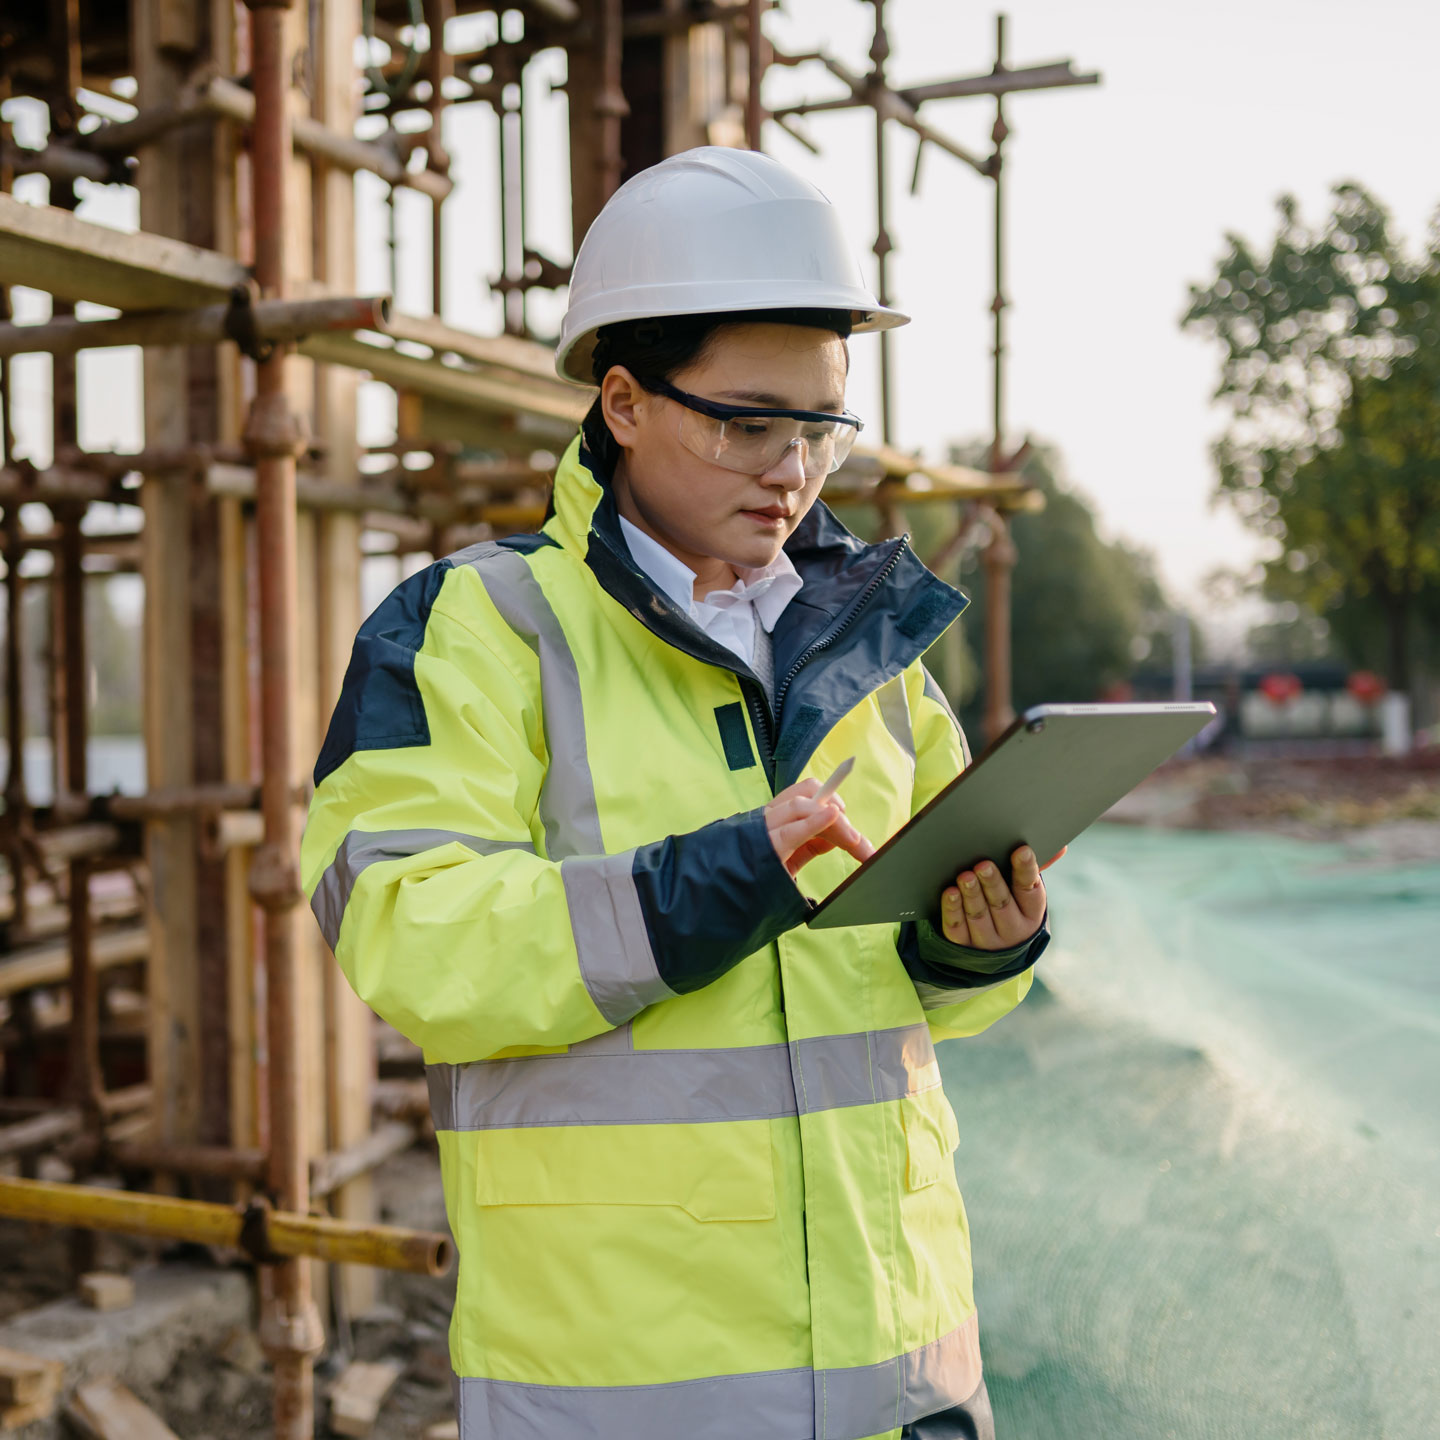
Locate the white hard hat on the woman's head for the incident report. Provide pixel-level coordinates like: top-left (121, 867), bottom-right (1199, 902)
top-left (554, 145), bottom-right (910, 384)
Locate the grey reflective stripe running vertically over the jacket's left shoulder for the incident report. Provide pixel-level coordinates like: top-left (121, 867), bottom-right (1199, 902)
top-left (451, 540), bottom-right (605, 860)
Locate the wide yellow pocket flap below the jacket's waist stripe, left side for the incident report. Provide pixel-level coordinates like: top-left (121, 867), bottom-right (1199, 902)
top-left (475, 1120), bottom-right (775, 1221)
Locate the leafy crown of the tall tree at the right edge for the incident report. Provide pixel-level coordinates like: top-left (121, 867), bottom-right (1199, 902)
top-left (1181, 184), bottom-right (1440, 690)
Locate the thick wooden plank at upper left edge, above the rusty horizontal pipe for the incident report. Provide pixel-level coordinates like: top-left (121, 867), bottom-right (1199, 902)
top-left (0, 192), bottom-right (248, 310)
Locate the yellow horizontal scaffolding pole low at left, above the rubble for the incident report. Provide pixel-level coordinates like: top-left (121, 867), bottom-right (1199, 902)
top-left (0, 1176), bottom-right (452, 1276)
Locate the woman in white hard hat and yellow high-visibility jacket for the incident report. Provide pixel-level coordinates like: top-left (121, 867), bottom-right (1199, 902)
top-left (305, 148), bottom-right (1045, 1440)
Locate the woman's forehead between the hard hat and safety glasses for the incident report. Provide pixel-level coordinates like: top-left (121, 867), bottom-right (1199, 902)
top-left (675, 324), bottom-right (848, 410)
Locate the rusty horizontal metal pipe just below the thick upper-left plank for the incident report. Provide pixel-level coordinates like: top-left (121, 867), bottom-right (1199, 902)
top-left (0, 295), bottom-right (390, 356)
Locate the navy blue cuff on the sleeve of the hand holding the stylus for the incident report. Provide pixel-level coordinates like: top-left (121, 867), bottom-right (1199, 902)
top-left (631, 809), bottom-right (811, 995)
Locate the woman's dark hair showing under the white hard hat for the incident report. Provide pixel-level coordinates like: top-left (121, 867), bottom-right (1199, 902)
top-left (580, 310), bottom-right (851, 475)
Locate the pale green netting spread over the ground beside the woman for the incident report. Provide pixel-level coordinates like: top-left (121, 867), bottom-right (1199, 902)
top-left (940, 827), bottom-right (1440, 1440)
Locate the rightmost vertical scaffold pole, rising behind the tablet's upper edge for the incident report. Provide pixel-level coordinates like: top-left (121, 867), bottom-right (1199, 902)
top-left (985, 14), bottom-right (1017, 740)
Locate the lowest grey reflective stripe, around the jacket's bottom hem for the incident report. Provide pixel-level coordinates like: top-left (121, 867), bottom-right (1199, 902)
top-left (455, 1315), bottom-right (982, 1440)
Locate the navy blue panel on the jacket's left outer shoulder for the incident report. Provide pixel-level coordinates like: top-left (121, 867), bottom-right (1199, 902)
top-left (315, 560), bottom-right (451, 788)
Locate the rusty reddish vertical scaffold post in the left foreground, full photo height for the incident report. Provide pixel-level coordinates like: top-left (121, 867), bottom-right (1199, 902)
top-left (245, 0), bottom-right (324, 1422)
